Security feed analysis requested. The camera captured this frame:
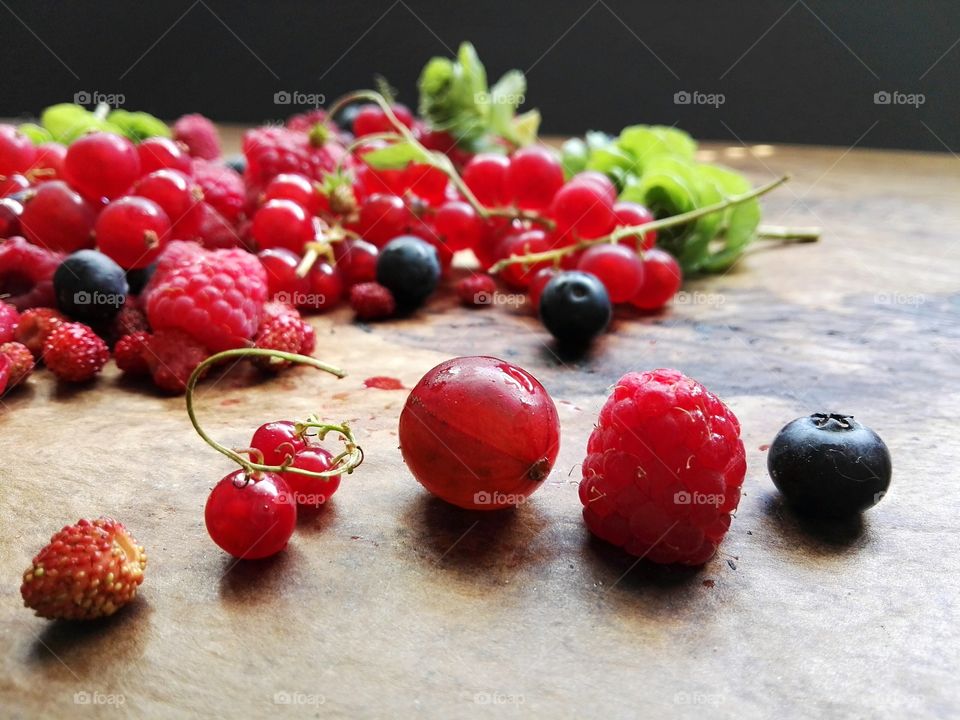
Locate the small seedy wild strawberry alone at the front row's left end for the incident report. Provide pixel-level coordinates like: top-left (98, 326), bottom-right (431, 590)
top-left (20, 518), bottom-right (147, 620)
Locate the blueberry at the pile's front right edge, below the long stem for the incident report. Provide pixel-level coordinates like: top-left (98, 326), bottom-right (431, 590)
top-left (540, 270), bottom-right (613, 345)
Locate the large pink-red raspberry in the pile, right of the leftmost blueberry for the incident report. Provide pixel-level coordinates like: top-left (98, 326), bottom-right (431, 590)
top-left (143, 241), bottom-right (267, 352)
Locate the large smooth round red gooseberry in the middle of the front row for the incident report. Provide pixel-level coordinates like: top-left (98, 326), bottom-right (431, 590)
top-left (399, 357), bottom-right (560, 510)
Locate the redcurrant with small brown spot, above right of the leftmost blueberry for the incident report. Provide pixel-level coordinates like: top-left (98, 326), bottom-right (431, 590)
top-left (95, 196), bottom-right (170, 270)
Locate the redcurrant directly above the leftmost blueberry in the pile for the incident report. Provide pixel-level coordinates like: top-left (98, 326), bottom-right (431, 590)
top-left (20, 180), bottom-right (97, 253)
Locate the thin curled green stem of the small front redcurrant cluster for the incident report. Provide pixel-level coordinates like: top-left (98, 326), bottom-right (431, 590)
top-left (186, 348), bottom-right (363, 478)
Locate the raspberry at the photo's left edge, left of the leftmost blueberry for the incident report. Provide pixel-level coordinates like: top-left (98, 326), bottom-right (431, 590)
top-left (0, 237), bottom-right (63, 311)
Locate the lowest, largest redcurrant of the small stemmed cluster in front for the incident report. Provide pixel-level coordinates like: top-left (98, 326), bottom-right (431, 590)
top-left (204, 470), bottom-right (297, 560)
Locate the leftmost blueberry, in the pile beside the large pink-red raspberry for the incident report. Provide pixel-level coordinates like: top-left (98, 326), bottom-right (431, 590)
top-left (53, 250), bottom-right (129, 324)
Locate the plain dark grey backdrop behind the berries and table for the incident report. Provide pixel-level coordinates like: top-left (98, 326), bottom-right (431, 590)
top-left (0, 0), bottom-right (960, 152)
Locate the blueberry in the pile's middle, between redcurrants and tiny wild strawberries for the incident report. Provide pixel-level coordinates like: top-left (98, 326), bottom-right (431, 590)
top-left (377, 235), bottom-right (440, 309)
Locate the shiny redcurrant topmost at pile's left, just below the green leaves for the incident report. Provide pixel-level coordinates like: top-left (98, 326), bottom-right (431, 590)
top-left (63, 132), bottom-right (140, 202)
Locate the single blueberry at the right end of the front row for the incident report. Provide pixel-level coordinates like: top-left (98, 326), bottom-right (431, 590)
top-left (767, 413), bottom-right (891, 517)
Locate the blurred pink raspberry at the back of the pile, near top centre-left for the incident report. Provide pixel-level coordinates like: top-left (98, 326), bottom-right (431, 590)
top-left (243, 126), bottom-right (350, 187)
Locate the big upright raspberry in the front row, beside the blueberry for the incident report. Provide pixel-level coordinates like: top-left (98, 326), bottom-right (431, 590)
top-left (580, 370), bottom-right (747, 565)
